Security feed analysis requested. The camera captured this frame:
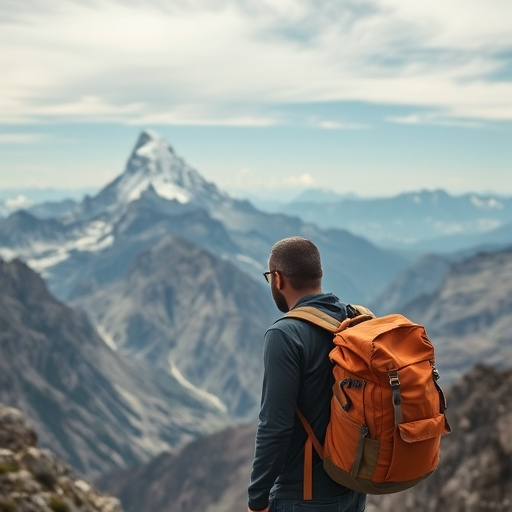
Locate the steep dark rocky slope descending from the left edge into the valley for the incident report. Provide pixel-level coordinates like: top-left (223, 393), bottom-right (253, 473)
top-left (0, 260), bottom-right (228, 476)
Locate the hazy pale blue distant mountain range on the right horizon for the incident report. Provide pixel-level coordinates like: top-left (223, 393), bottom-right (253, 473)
top-left (258, 190), bottom-right (512, 253)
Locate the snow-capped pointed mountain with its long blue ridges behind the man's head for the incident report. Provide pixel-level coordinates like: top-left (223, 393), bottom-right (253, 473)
top-left (0, 131), bottom-right (409, 302)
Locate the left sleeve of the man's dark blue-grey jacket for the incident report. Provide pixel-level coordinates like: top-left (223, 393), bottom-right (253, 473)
top-left (248, 327), bottom-right (301, 510)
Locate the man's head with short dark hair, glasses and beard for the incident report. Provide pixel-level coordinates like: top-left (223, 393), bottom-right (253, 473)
top-left (268, 236), bottom-right (323, 313)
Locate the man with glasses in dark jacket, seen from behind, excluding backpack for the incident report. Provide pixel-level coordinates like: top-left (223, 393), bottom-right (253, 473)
top-left (248, 237), bottom-right (366, 512)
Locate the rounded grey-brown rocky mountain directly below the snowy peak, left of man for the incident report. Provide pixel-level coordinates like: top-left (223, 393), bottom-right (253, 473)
top-left (71, 236), bottom-right (277, 419)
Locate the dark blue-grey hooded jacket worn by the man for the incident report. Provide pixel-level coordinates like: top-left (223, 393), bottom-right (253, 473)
top-left (249, 294), bottom-right (360, 510)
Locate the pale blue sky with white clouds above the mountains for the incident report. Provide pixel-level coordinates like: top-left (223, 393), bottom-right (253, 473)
top-left (0, 0), bottom-right (512, 202)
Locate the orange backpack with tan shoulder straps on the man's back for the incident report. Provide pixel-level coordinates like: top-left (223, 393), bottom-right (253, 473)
top-left (286, 306), bottom-right (451, 500)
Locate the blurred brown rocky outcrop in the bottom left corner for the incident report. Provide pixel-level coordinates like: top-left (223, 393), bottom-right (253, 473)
top-left (0, 404), bottom-right (122, 512)
